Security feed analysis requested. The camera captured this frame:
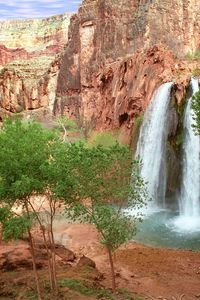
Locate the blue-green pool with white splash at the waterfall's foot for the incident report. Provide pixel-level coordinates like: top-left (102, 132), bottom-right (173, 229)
top-left (134, 210), bottom-right (200, 250)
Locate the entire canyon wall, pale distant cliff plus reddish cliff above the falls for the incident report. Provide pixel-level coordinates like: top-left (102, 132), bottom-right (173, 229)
top-left (0, 0), bottom-right (200, 133)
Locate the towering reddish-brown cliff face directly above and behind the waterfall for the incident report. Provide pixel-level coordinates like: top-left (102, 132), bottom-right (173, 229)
top-left (54, 0), bottom-right (200, 136)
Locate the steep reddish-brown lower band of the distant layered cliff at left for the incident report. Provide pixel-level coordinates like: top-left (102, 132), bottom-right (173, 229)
top-left (0, 57), bottom-right (60, 112)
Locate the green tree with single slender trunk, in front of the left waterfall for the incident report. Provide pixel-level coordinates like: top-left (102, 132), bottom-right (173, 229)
top-left (57, 144), bottom-right (147, 291)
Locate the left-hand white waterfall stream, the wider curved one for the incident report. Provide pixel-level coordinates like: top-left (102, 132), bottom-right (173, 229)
top-left (136, 82), bottom-right (173, 207)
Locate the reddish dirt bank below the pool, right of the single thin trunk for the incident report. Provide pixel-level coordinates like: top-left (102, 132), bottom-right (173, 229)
top-left (117, 244), bottom-right (200, 300)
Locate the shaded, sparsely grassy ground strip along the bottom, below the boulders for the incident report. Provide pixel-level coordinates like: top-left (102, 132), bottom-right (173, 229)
top-left (0, 268), bottom-right (144, 300)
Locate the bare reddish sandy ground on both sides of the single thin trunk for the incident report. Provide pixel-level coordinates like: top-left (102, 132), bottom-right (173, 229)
top-left (52, 222), bottom-right (200, 300)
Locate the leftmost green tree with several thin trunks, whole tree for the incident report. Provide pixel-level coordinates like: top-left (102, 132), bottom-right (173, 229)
top-left (0, 119), bottom-right (59, 299)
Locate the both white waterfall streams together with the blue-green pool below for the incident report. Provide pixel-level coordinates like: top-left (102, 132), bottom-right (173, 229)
top-left (129, 79), bottom-right (200, 250)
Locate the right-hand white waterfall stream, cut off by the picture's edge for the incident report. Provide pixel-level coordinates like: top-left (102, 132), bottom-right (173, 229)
top-left (175, 78), bottom-right (200, 231)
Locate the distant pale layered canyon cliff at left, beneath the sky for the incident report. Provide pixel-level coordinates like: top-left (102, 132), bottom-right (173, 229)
top-left (0, 14), bottom-right (71, 112)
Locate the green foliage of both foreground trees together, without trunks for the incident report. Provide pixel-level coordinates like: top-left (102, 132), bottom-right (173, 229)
top-left (0, 120), bottom-right (147, 250)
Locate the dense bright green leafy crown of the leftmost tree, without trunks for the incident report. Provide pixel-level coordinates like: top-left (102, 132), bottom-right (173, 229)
top-left (0, 119), bottom-right (57, 201)
